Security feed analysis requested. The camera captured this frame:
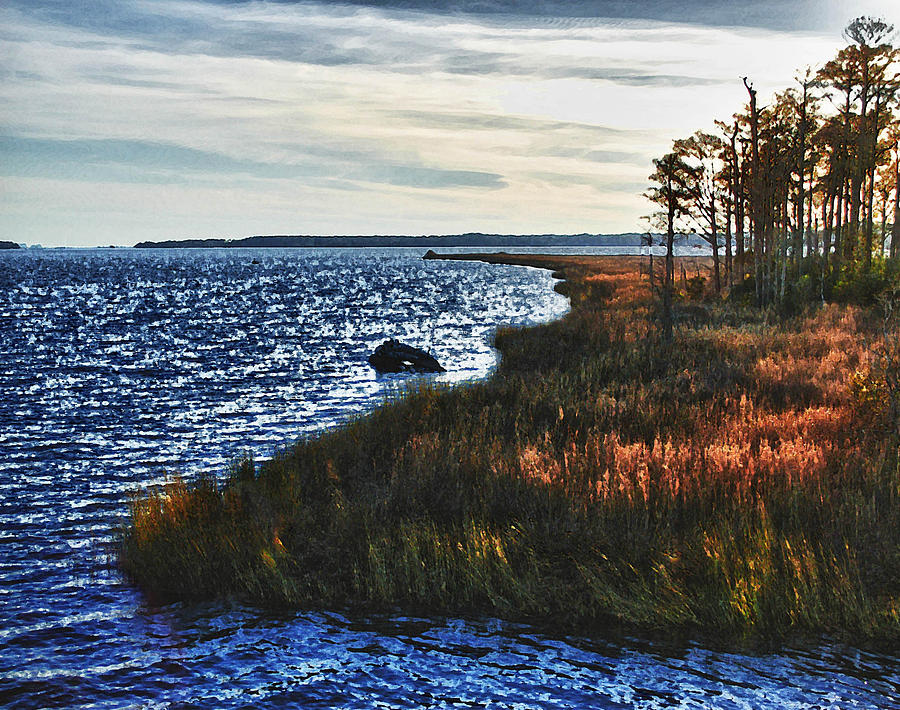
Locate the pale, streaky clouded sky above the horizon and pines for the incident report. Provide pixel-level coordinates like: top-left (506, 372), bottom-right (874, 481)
top-left (0, 0), bottom-right (900, 246)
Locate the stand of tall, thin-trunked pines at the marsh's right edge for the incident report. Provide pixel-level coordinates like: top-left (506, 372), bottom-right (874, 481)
top-left (647, 17), bottom-right (900, 318)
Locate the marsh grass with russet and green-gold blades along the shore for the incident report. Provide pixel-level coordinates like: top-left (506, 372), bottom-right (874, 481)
top-left (120, 255), bottom-right (900, 643)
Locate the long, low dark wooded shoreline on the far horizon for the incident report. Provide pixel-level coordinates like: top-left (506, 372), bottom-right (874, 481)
top-left (135, 232), bottom-right (699, 249)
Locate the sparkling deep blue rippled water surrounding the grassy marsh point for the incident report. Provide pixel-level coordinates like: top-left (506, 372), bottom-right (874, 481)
top-left (0, 250), bottom-right (900, 708)
